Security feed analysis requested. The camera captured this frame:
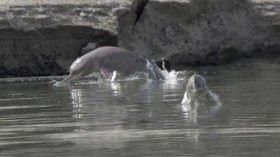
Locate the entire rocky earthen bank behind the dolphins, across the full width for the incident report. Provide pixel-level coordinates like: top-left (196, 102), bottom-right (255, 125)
top-left (0, 0), bottom-right (280, 77)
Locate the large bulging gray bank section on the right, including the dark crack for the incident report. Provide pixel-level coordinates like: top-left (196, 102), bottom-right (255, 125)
top-left (118, 0), bottom-right (280, 67)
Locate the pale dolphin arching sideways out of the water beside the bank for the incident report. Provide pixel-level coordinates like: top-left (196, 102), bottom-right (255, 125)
top-left (60, 46), bottom-right (165, 84)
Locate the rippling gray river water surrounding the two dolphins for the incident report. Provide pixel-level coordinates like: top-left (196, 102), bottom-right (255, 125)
top-left (0, 59), bottom-right (280, 157)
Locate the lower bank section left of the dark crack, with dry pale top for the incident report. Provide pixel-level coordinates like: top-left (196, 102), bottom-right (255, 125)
top-left (0, 0), bottom-right (126, 77)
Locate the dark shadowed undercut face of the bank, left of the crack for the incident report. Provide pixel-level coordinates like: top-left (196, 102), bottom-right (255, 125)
top-left (0, 26), bottom-right (117, 77)
